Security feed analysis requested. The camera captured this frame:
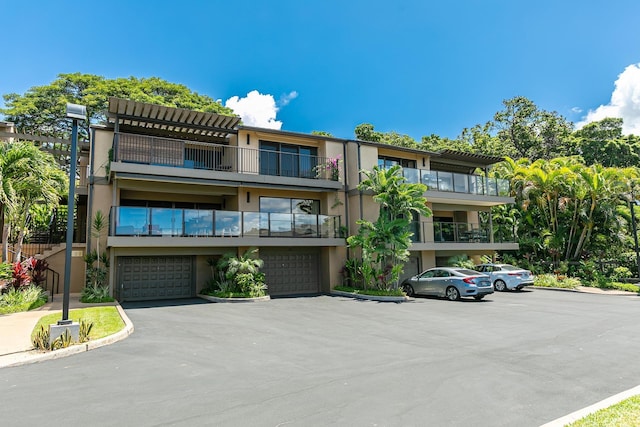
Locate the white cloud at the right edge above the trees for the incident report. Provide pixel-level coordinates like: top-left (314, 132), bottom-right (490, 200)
top-left (576, 64), bottom-right (640, 135)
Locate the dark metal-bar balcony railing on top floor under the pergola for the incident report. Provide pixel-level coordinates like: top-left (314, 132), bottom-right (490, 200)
top-left (113, 133), bottom-right (339, 181)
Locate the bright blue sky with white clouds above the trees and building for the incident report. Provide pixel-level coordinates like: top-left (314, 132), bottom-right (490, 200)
top-left (0, 0), bottom-right (640, 140)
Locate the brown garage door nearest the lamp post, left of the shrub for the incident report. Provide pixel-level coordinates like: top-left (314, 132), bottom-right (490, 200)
top-left (118, 256), bottom-right (195, 301)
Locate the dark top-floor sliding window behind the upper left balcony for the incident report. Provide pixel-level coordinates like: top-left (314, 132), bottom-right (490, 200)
top-left (260, 141), bottom-right (318, 178)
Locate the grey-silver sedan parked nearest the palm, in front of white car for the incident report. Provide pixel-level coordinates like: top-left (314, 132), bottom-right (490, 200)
top-left (402, 267), bottom-right (493, 301)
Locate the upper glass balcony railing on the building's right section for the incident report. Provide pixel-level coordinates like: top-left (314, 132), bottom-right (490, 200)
top-left (392, 168), bottom-right (509, 196)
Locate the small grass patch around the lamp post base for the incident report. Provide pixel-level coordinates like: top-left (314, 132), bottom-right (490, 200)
top-left (31, 306), bottom-right (124, 340)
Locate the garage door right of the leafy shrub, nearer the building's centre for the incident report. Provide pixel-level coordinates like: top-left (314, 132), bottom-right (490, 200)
top-left (260, 248), bottom-right (320, 296)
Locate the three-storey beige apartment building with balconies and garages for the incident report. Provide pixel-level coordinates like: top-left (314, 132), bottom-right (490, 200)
top-left (81, 98), bottom-right (517, 301)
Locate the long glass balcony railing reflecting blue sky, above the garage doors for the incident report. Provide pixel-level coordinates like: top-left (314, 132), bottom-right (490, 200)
top-left (110, 206), bottom-right (340, 238)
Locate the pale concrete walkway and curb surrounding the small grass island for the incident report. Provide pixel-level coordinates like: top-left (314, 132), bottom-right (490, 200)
top-left (0, 294), bottom-right (133, 368)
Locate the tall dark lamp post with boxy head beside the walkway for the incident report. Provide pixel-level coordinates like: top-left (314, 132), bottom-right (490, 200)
top-left (58, 104), bottom-right (87, 325)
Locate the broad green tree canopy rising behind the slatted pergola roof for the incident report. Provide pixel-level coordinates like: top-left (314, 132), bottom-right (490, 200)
top-left (0, 73), bottom-right (233, 139)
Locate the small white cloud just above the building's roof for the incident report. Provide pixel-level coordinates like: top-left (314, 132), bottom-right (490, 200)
top-left (224, 90), bottom-right (282, 129)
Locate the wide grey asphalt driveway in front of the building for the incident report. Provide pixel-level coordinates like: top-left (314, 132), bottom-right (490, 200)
top-left (0, 290), bottom-right (640, 426)
